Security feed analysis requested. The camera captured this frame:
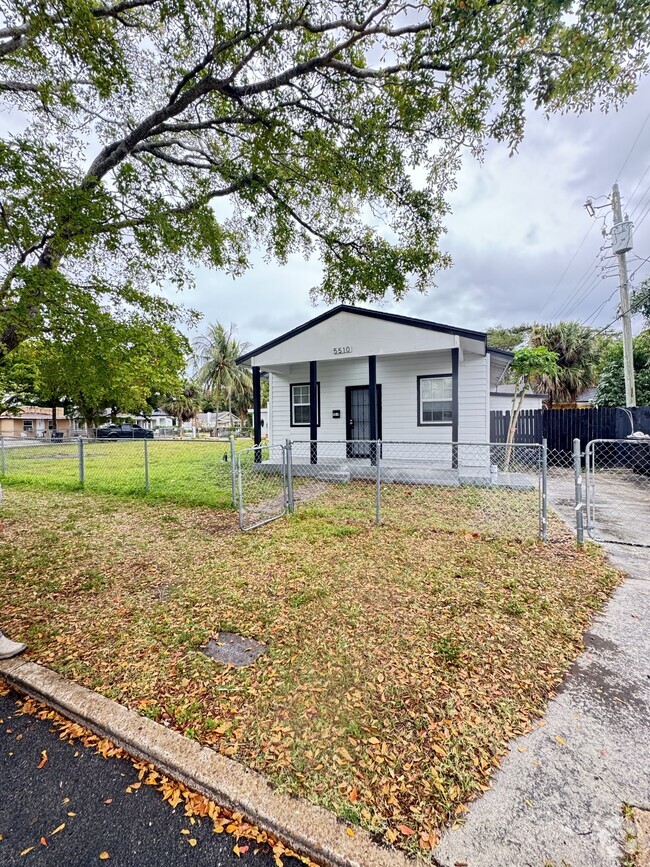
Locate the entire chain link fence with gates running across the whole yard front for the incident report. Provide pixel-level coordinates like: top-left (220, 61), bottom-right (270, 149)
top-left (0, 436), bottom-right (650, 546)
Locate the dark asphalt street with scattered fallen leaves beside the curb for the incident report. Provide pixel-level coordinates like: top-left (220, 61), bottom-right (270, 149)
top-left (0, 693), bottom-right (300, 867)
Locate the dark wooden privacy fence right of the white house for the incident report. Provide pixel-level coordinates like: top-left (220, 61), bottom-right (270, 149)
top-left (490, 406), bottom-right (650, 452)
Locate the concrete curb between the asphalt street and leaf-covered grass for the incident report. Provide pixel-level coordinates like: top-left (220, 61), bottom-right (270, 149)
top-left (0, 658), bottom-right (415, 867)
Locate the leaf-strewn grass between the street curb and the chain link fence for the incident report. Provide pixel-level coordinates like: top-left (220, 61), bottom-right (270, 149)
top-left (0, 486), bottom-right (618, 851)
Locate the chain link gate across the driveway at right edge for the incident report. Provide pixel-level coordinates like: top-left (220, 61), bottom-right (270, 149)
top-left (585, 438), bottom-right (650, 547)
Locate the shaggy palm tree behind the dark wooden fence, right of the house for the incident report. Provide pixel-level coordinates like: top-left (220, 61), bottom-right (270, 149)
top-left (529, 322), bottom-right (600, 409)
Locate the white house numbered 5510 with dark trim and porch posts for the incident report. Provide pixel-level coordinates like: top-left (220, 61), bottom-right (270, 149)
top-left (238, 304), bottom-right (512, 463)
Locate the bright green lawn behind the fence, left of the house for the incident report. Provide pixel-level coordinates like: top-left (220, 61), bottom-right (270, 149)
top-left (2, 439), bottom-right (252, 508)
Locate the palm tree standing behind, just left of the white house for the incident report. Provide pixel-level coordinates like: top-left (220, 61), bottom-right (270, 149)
top-left (194, 322), bottom-right (252, 435)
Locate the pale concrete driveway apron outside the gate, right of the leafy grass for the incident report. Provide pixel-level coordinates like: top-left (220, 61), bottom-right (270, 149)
top-left (434, 492), bottom-right (650, 867)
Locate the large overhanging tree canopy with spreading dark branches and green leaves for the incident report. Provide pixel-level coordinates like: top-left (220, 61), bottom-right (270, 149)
top-left (0, 0), bottom-right (649, 354)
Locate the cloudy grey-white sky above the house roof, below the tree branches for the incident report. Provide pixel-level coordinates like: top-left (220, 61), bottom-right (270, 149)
top-left (183, 78), bottom-right (650, 354)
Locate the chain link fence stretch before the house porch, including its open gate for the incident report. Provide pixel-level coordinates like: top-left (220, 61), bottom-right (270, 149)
top-left (239, 440), bottom-right (547, 539)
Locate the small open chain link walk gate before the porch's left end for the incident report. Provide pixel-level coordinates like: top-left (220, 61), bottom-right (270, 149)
top-left (237, 444), bottom-right (288, 530)
